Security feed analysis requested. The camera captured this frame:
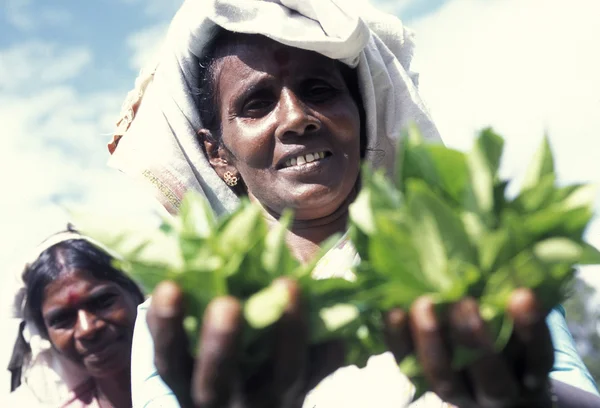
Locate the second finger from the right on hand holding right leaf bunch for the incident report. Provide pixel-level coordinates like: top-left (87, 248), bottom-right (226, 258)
top-left (448, 298), bottom-right (518, 408)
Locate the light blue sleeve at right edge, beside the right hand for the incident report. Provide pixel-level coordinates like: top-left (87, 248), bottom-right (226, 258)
top-left (546, 305), bottom-right (598, 395)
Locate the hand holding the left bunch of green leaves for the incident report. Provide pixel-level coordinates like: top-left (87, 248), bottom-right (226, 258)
top-left (147, 279), bottom-right (344, 408)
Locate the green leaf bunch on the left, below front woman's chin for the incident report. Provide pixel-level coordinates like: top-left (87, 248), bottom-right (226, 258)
top-left (78, 196), bottom-right (376, 378)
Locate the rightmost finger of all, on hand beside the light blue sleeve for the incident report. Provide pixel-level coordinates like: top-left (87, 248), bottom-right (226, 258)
top-left (508, 289), bottom-right (554, 393)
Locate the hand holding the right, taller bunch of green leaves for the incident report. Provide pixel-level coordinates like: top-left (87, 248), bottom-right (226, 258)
top-left (385, 289), bottom-right (554, 408)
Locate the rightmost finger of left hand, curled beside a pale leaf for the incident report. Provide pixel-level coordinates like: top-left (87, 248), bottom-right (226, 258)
top-left (273, 279), bottom-right (308, 406)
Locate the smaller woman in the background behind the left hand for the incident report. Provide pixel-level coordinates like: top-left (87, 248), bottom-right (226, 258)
top-left (2, 229), bottom-right (144, 408)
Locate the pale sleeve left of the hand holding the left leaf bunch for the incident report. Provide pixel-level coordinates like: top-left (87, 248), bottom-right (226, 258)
top-left (131, 299), bottom-right (180, 408)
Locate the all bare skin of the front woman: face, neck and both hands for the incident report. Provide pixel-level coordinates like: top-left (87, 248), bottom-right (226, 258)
top-left (147, 33), bottom-right (572, 408)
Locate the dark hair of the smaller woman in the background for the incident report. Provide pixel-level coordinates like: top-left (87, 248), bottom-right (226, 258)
top-left (23, 239), bottom-right (144, 337)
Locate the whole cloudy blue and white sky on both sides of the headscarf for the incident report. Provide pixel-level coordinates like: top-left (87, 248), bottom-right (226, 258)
top-left (0, 0), bottom-right (600, 287)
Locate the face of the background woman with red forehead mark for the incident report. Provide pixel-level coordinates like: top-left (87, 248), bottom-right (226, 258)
top-left (42, 271), bottom-right (137, 377)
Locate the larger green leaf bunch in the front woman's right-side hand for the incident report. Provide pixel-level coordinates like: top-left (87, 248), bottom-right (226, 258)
top-left (350, 128), bottom-right (600, 396)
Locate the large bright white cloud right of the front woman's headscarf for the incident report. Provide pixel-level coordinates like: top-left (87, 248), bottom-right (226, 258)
top-left (412, 0), bottom-right (600, 288)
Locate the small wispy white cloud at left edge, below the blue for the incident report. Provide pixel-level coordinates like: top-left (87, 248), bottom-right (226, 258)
top-left (0, 41), bottom-right (92, 91)
